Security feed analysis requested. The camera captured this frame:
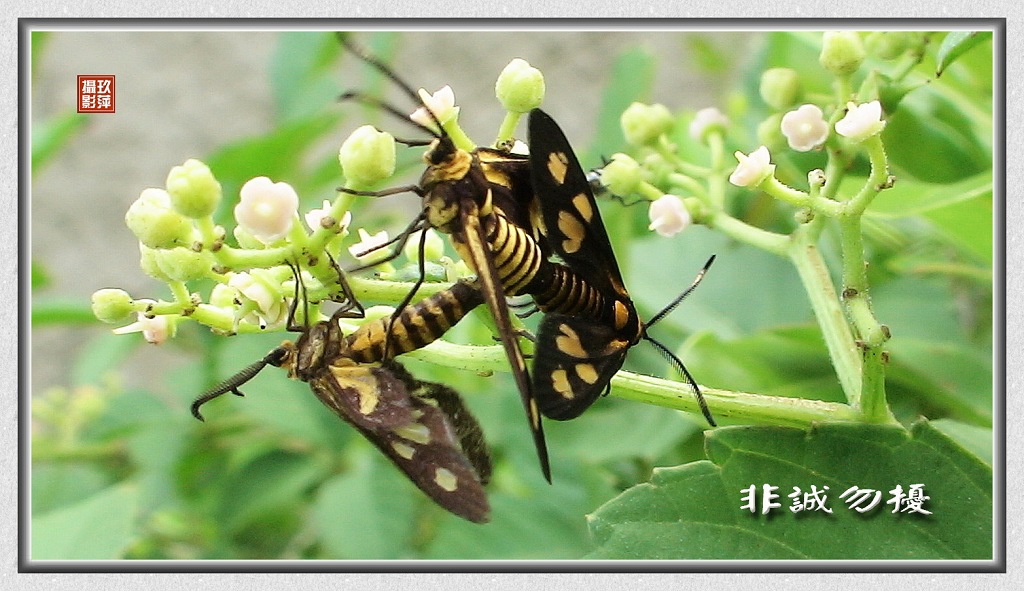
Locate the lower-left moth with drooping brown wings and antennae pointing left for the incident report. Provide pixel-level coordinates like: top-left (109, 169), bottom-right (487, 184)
top-left (191, 281), bottom-right (490, 523)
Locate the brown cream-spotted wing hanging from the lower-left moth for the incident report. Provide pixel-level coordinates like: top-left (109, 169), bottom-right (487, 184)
top-left (309, 361), bottom-right (490, 523)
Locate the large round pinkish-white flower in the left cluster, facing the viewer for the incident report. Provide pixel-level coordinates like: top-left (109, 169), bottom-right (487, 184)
top-left (234, 176), bottom-right (299, 244)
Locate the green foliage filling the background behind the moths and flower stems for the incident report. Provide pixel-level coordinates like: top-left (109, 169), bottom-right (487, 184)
top-left (32, 32), bottom-right (1002, 560)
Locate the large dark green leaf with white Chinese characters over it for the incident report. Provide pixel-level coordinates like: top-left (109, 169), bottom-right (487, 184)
top-left (589, 422), bottom-right (993, 560)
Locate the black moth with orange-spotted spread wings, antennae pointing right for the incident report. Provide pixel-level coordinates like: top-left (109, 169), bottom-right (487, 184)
top-left (528, 109), bottom-right (715, 425)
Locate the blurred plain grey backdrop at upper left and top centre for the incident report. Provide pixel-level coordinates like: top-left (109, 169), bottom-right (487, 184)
top-left (28, 30), bottom-right (757, 393)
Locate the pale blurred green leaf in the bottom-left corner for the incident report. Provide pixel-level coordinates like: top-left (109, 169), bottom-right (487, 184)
top-left (32, 484), bottom-right (138, 560)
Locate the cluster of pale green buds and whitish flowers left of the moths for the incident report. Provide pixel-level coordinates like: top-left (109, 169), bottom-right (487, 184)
top-left (92, 54), bottom-right (557, 343)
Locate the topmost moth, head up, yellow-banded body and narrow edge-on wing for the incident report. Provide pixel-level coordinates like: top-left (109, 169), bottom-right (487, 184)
top-left (339, 35), bottom-right (551, 481)
